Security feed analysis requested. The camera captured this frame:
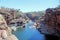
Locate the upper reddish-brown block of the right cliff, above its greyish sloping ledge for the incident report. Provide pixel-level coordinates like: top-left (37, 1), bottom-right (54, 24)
top-left (45, 9), bottom-right (60, 24)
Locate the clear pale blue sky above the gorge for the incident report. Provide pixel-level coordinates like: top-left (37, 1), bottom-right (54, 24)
top-left (0, 0), bottom-right (59, 12)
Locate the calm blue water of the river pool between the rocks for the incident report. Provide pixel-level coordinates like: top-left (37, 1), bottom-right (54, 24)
top-left (14, 22), bottom-right (45, 40)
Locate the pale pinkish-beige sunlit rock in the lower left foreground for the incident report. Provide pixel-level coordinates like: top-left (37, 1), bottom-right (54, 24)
top-left (0, 14), bottom-right (18, 40)
